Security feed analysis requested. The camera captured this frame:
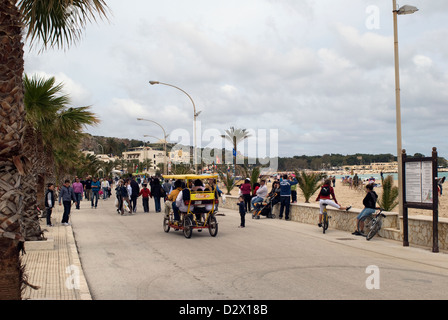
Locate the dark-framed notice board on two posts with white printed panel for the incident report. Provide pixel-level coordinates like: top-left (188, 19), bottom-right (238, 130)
top-left (402, 148), bottom-right (439, 252)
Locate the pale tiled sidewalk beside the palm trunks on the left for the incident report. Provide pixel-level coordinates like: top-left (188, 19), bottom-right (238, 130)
top-left (21, 201), bottom-right (92, 300)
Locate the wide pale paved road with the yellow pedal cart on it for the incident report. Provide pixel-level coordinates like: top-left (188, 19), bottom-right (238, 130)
top-left (72, 195), bottom-right (448, 300)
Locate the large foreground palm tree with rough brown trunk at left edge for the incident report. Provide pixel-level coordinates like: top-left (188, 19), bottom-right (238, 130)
top-left (0, 0), bottom-right (107, 300)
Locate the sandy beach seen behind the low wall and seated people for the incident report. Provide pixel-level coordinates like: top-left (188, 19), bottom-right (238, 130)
top-left (223, 179), bottom-right (448, 218)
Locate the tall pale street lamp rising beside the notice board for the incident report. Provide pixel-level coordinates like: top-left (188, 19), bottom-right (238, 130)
top-left (392, 0), bottom-right (418, 222)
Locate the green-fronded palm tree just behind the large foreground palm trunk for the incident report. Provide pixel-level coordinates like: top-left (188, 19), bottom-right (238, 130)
top-left (23, 75), bottom-right (99, 215)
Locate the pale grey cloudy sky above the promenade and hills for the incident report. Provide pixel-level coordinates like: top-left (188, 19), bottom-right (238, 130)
top-left (25, 0), bottom-right (448, 158)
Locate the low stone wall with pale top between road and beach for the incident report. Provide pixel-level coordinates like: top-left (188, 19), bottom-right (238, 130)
top-left (220, 196), bottom-right (448, 250)
